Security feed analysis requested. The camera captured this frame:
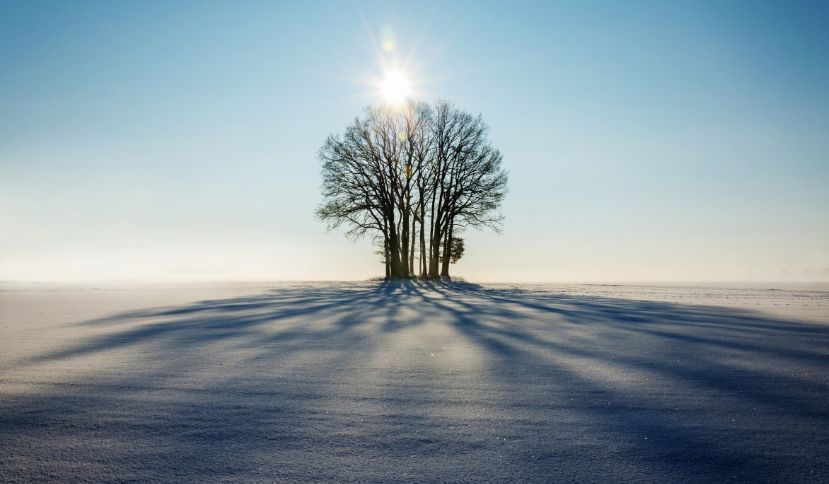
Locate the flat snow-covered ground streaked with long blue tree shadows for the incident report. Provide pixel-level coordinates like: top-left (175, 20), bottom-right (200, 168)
top-left (0, 282), bottom-right (829, 482)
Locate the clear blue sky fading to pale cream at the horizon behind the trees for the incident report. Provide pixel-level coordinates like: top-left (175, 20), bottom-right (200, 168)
top-left (0, 0), bottom-right (829, 282)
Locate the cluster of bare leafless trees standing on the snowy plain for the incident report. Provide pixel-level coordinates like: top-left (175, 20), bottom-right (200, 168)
top-left (317, 102), bottom-right (507, 278)
